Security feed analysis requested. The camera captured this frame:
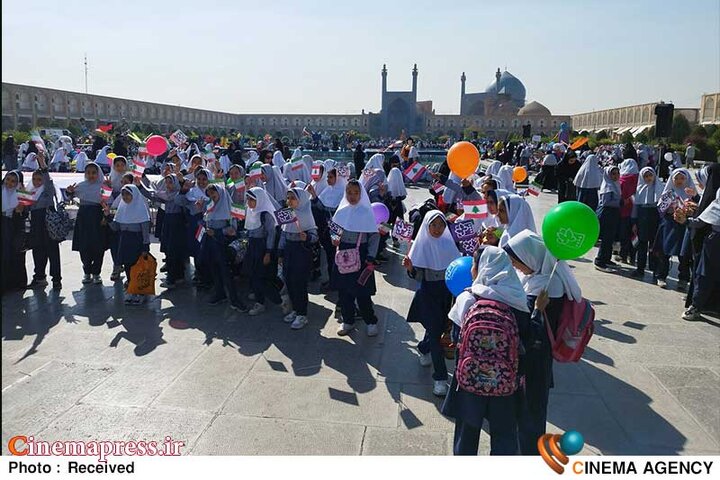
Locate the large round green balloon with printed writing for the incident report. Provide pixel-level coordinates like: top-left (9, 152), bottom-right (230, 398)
top-left (542, 202), bottom-right (600, 260)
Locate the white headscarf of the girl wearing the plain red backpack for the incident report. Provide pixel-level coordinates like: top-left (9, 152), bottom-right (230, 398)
top-left (506, 230), bottom-right (582, 302)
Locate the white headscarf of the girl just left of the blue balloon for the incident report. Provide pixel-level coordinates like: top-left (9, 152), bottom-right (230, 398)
top-left (408, 210), bottom-right (460, 270)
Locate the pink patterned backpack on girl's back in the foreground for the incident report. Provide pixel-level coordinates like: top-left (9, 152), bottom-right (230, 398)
top-left (455, 298), bottom-right (520, 397)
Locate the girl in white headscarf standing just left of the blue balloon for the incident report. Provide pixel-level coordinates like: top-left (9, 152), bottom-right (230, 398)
top-left (403, 210), bottom-right (460, 396)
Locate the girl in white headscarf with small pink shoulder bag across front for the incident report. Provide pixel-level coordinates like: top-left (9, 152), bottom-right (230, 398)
top-left (331, 180), bottom-right (380, 337)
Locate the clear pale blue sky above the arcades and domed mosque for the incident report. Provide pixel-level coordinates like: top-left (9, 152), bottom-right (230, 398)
top-left (2, 0), bottom-right (720, 114)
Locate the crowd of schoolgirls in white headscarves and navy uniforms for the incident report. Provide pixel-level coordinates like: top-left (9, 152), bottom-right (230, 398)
top-left (2, 138), bottom-right (720, 455)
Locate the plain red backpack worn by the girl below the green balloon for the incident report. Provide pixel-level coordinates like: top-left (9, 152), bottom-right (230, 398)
top-left (545, 297), bottom-right (595, 363)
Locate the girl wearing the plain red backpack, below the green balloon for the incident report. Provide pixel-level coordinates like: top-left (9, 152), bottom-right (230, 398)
top-left (505, 230), bottom-right (582, 455)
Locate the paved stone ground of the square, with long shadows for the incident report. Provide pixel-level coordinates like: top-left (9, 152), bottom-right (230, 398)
top-left (2, 189), bottom-right (720, 455)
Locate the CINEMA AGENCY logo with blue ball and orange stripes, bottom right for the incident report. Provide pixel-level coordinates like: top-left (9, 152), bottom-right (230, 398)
top-left (538, 430), bottom-right (713, 476)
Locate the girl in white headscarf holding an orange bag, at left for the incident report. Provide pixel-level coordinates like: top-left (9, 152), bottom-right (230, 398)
top-left (105, 185), bottom-right (150, 305)
